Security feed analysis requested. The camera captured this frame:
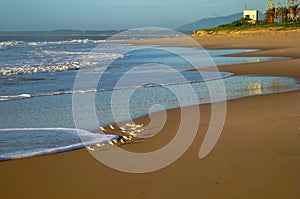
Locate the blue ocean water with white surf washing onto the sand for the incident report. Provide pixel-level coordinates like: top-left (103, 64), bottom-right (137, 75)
top-left (0, 32), bottom-right (299, 160)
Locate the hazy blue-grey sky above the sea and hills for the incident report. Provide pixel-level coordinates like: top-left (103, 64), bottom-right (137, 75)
top-left (0, 0), bottom-right (282, 31)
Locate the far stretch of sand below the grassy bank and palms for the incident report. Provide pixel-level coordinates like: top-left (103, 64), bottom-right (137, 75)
top-left (120, 31), bottom-right (300, 81)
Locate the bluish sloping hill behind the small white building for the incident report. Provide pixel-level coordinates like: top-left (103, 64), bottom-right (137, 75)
top-left (176, 12), bottom-right (264, 31)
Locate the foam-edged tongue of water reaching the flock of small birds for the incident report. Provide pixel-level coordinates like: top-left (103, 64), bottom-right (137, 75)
top-left (0, 128), bottom-right (117, 161)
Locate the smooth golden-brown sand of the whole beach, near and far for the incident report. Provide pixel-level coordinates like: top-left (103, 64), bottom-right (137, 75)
top-left (0, 32), bottom-right (300, 199)
